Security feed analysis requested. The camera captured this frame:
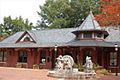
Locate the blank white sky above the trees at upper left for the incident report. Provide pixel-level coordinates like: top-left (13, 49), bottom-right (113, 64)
top-left (0, 0), bottom-right (45, 25)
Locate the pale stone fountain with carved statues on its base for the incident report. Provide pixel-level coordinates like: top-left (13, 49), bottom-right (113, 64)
top-left (48, 55), bottom-right (96, 80)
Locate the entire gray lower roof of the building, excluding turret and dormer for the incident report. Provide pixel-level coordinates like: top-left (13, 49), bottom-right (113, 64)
top-left (0, 28), bottom-right (120, 48)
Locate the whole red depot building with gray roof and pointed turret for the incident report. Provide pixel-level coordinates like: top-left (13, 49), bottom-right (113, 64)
top-left (0, 13), bottom-right (120, 71)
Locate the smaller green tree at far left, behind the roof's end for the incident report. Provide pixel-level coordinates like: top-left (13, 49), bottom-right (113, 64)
top-left (0, 16), bottom-right (33, 36)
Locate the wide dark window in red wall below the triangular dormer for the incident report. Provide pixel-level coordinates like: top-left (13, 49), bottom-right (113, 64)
top-left (18, 51), bottom-right (27, 63)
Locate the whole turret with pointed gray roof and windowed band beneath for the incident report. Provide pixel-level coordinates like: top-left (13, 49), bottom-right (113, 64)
top-left (72, 11), bottom-right (108, 40)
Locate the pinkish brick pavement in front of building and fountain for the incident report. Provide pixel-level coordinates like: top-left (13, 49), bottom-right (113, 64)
top-left (0, 67), bottom-right (120, 80)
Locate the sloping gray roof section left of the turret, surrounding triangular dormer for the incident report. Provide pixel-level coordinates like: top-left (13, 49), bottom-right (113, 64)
top-left (0, 28), bottom-right (76, 48)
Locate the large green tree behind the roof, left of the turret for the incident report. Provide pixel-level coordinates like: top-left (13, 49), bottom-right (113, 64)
top-left (36, 0), bottom-right (99, 28)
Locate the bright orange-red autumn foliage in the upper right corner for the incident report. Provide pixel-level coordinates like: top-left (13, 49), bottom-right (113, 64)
top-left (96, 0), bottom-right (120, 27)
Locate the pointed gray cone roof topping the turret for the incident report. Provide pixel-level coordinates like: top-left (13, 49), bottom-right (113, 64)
top-left (79, 11), bottom-right (101, 30)
